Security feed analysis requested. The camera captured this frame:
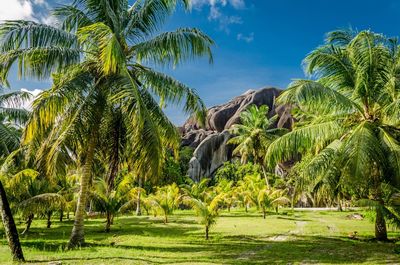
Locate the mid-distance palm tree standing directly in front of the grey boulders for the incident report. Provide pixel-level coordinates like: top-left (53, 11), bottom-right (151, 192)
top-left (228, 105), bottom-right (285, 186)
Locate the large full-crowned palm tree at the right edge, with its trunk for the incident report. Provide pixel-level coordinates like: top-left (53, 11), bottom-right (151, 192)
top-left (266, 31), bottom-right (400, 240)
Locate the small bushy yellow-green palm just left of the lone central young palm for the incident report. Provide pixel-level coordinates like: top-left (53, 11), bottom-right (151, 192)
top-left (152, 183), bottom-right (181, 224)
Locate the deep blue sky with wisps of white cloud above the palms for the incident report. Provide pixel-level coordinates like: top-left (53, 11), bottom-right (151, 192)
top-left (0, 0), bottom-right (400, 125)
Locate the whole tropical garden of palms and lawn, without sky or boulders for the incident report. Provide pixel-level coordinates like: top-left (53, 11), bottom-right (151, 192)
top-left (0, 0), bottom-right (400, 264)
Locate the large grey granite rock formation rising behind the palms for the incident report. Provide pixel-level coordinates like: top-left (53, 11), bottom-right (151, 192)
top-left (181, 88), bottom-right (293, 181)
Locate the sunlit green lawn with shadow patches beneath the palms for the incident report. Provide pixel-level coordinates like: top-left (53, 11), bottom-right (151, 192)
top-left (0, 211), bottom-right (400, 265)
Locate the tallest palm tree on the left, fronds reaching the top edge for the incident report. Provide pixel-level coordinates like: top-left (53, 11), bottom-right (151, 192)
top-left (0, 0), bottom-right (213, 247)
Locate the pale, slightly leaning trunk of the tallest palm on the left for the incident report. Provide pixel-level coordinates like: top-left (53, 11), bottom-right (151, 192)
top-left (67, 137), bottom-right (96, 249)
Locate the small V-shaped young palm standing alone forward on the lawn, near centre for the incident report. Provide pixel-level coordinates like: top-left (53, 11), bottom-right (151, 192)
top-left (184, 191), bottom-right (224, 240)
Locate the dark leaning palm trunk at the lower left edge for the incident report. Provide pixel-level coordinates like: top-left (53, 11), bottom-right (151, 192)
top-left (0, 178), bottom-right (25, 262)
